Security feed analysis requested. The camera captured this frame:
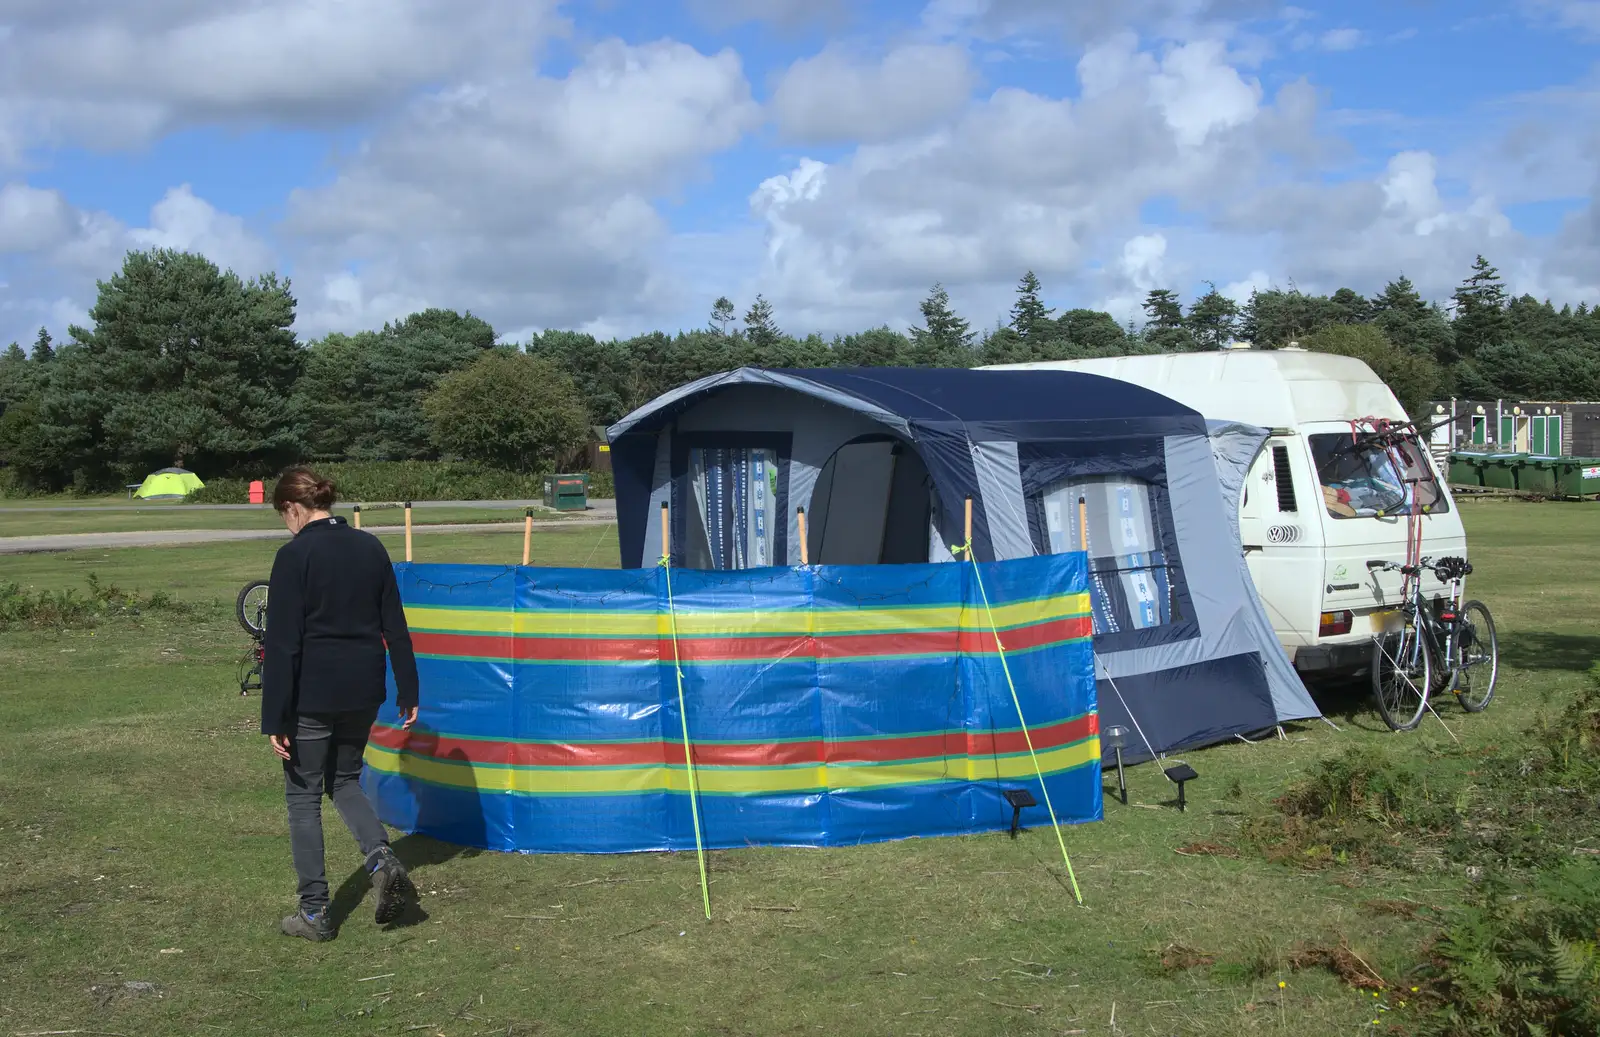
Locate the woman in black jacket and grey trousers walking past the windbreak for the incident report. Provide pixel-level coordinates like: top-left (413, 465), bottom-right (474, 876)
top-left (261, 467), bottom-right (418, 941)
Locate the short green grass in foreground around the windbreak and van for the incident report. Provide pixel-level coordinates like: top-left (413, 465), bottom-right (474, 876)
top-left (0, 504), bottom-right (1600, 1037)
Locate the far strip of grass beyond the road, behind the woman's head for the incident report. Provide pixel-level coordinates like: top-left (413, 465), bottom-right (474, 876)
top-left (0, 502), bottom-right (595, 536)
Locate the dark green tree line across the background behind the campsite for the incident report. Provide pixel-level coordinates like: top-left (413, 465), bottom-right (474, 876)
top-left (0, 250), bottom-right (1600, 490)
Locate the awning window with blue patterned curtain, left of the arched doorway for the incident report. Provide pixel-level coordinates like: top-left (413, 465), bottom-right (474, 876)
top-left (686, 446), bottom-right (782, 570)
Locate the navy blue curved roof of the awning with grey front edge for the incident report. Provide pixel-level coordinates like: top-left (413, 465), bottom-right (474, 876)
top-left (608, 368), bottom-right (1206, 445)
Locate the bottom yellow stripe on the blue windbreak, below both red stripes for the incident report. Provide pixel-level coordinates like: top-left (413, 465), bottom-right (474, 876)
top-left (366, 738), bottom-right (1101, 795)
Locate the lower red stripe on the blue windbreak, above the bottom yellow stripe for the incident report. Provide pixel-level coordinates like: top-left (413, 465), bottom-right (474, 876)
top-left (371, 714), bottom-right (1099, 767)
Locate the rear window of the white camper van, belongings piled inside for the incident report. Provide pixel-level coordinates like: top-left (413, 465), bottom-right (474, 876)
top-left (1309, 432), bottom-right (1448, 519)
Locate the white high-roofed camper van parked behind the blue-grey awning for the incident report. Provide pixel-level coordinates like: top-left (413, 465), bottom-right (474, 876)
top-left (979, 347), bottom-right (1467, 677)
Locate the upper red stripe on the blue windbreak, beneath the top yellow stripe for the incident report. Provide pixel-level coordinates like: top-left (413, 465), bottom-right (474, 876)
top-left (411, 616), bottom-right (1093, 663)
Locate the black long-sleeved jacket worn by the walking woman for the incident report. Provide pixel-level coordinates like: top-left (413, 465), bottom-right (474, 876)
top-left (261, 519), bottom-right (418, 735)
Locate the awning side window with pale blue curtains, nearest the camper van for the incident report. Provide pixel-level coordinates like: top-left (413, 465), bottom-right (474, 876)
top-left (1042, 475), bottom-right (1179, 634)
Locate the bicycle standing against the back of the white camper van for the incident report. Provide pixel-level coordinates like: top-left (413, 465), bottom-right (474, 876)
top-left (1366, 557), bottom-right (1499, 731)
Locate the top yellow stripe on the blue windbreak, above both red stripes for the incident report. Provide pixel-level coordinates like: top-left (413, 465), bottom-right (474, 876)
top-left (405, 594), bottom-right (1090, 637)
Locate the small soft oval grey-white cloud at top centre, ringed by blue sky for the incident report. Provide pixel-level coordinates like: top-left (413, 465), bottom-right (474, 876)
top-left (771, 43), bottom-right (978, 144)
